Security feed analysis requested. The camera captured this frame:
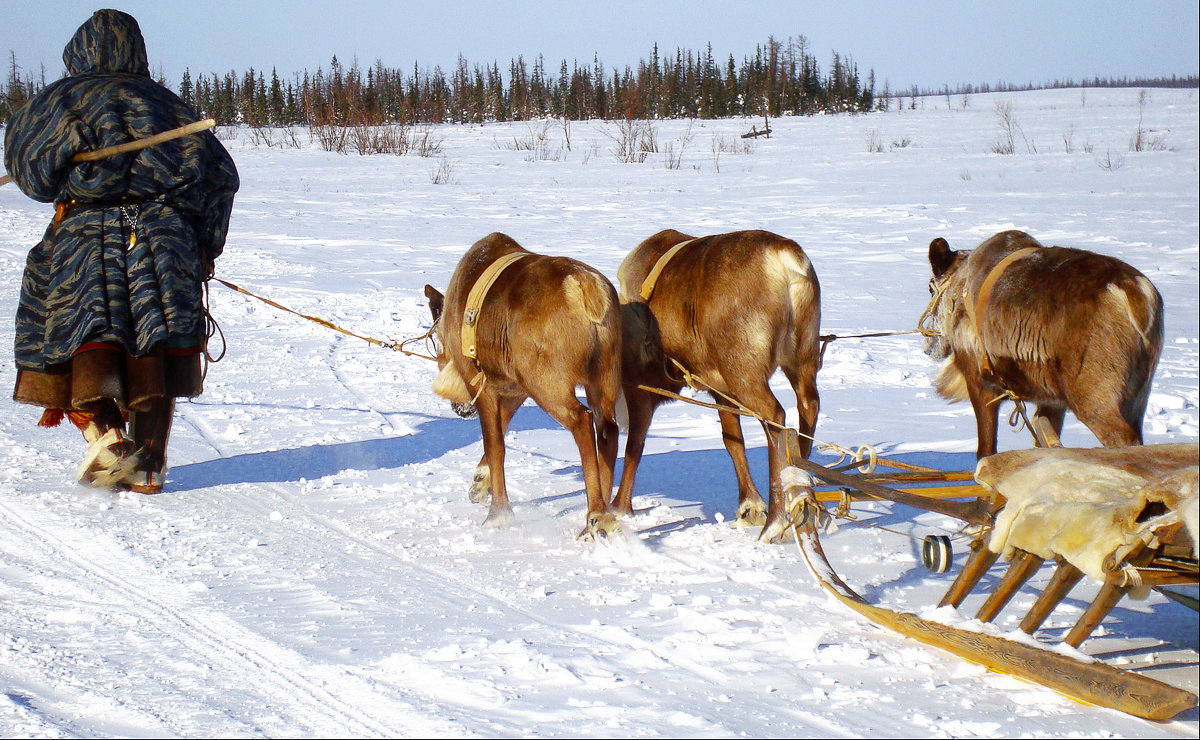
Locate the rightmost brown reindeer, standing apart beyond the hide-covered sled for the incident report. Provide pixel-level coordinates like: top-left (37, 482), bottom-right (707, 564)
top-left (925, 231), bottom-right (1163, 457)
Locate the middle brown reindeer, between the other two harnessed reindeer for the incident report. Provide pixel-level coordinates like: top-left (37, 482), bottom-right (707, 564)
top-left (613, 230), bottom-right (821, 541)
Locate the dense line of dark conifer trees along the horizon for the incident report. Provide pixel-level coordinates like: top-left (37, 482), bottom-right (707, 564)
top-left (0, 36), bottom-right (878, 127)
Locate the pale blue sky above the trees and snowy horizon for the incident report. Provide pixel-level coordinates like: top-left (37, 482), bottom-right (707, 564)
top-left (0, 0), bottom-right (1200, 91)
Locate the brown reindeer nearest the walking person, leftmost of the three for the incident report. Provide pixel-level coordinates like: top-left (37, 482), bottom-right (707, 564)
top-left (425, 234), bottom-right (620, 539)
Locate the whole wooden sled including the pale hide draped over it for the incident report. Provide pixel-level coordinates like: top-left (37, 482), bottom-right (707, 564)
top-left (787, 432), bottom-right (1200, 721)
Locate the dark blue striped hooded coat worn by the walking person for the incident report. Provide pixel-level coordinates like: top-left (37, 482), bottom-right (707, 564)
top-left (5, 10), bottom-right (239, 372)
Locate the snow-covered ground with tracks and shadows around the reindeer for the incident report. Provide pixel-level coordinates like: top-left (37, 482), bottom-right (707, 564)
top-left (0, 89), bottom-right (1200, 738)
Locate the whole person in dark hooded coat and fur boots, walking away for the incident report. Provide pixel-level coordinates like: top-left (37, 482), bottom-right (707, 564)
top-left (5, 10), bottom-right (239, 493)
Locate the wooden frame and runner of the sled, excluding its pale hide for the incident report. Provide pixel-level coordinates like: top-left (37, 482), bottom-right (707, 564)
top-left (786, 431), bottom-right (1198, 721)
